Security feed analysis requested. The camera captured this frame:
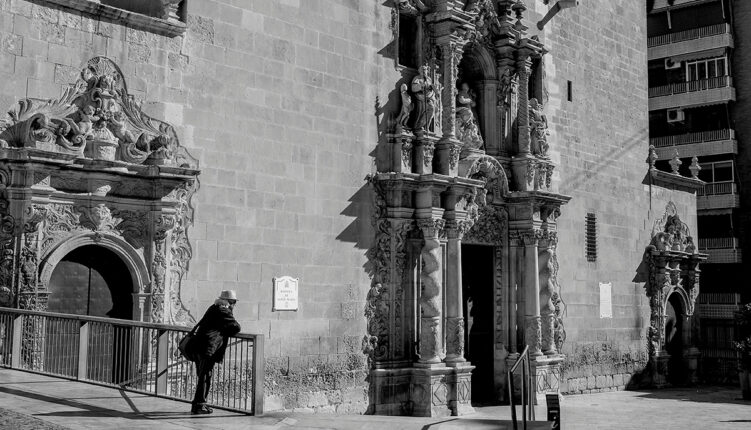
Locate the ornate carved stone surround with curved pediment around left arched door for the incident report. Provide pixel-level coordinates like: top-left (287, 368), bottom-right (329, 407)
top-left (0, 57), bottom-right (199, 324)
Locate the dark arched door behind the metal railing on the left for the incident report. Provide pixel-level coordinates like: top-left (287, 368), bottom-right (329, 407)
top-left (45, 245), bottom-right (133, 383)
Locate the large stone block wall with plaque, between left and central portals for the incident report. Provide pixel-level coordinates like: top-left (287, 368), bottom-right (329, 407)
top-left (0, 0), bottom-right (398, 412)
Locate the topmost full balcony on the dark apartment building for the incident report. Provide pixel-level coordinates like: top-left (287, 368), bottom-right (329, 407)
top-left (647, 23), bottom-right (735, 60)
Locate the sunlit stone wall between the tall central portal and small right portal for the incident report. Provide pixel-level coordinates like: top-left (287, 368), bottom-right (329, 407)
top-left (527, 0), bottom-right (696, 392)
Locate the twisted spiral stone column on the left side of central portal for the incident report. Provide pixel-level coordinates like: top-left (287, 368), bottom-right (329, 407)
top-left (417, 218), bottom-right (445, 364)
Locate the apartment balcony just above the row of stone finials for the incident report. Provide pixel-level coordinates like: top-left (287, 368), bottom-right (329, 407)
top-left (649, 129), bottom-right (738, 160)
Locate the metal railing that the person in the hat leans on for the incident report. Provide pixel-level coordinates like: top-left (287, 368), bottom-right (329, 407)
top-left (0, 308), bottom-right (264, 415)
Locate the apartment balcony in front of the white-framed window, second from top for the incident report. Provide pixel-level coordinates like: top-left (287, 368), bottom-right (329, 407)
top-left (649, 76), bottom-right (735, 111)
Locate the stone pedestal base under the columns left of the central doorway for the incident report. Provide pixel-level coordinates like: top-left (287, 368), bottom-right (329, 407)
top-left (370, 362), bottom-right (475, 417)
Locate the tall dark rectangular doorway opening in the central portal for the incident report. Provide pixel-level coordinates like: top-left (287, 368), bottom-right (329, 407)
top-left (462, 245), bottom-right (498, 406)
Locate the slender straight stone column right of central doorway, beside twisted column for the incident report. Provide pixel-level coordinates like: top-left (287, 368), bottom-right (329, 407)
top-left (523, 232), bottom-right (542, 357)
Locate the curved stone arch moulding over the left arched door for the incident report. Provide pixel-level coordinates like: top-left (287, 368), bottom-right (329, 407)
top-left (39, 232), bottom-right (151, 300)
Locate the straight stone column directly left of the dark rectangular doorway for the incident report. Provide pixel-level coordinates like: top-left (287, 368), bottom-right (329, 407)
top-left (446, 220), bottom-right (467, 363)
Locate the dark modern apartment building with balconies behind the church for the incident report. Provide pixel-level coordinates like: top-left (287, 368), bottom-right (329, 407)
top-left (647, 0), bottom-right (751, 380)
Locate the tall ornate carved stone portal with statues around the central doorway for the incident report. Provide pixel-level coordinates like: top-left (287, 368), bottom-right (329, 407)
top-left (364, 0), bottom-right (570, 416)
